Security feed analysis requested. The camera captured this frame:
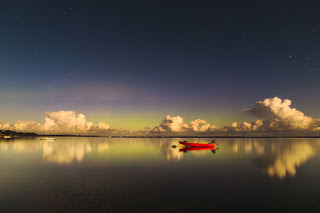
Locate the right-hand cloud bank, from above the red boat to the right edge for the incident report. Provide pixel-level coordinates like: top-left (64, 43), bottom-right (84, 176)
top-left (151, 97), bottom-right (320, 133)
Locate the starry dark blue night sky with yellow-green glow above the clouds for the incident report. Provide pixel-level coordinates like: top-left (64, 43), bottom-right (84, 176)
top-left (0, 0), bottom-right (320, 129)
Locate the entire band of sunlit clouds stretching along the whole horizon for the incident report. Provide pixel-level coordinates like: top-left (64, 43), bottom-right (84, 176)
top-left (0, 97), bottom-right (320, 135)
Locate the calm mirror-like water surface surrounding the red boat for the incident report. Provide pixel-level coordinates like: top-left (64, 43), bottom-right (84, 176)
top-left (0, 137), bottom-right (320, 213)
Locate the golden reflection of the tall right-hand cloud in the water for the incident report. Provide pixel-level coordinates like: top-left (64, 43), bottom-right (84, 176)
top-left (230, 139), bottom-right (319, 179)
